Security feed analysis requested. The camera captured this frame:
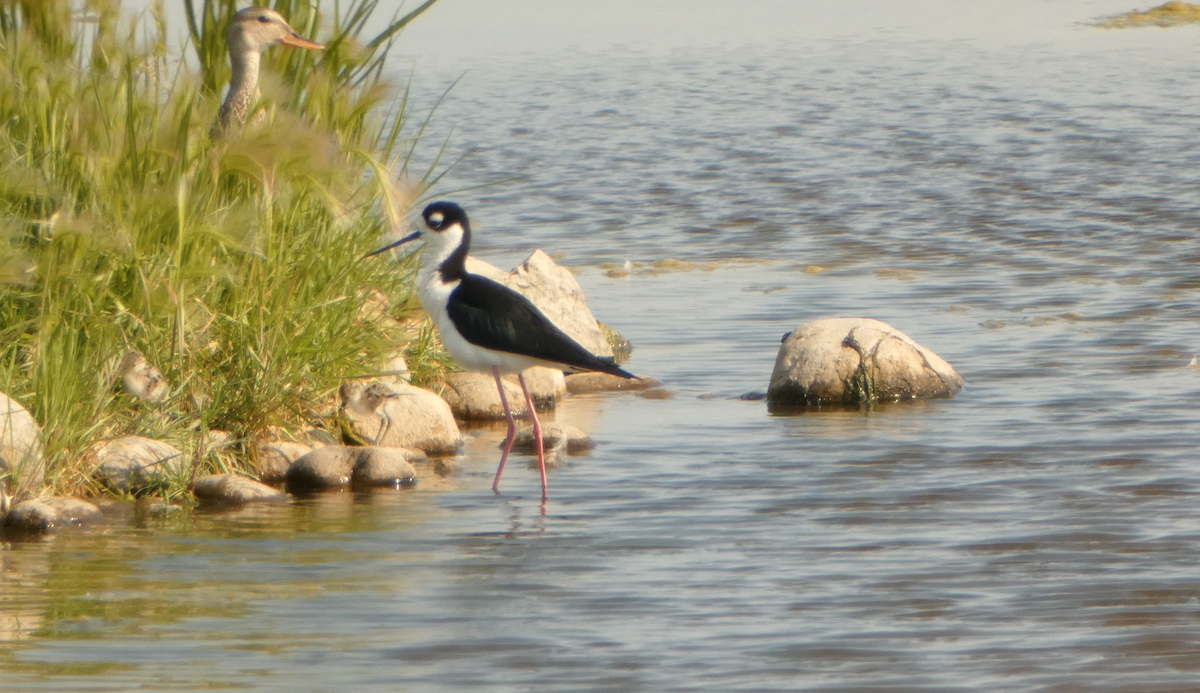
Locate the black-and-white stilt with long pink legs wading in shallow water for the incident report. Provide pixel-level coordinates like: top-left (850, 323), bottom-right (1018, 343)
top-left (368, 201), bottom-right (637, 501)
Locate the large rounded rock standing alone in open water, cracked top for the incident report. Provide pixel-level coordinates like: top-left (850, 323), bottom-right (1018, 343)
top-left (767, 318), bottom-right (965, 406)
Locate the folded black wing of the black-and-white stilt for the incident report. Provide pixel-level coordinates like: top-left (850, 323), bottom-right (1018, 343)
top-left (446, 273), bottom-right (636, 378)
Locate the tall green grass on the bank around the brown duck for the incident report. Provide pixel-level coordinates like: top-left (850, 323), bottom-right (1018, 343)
top-left (0, 0), bottom-right (444, 493)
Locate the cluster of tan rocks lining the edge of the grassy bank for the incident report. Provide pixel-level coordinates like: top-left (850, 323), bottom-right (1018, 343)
top-left (0, 251), bottom-right (658, 532)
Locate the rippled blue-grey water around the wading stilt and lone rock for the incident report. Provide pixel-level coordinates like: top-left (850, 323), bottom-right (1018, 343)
top-left (0, 6), bottom-right (1200, 692)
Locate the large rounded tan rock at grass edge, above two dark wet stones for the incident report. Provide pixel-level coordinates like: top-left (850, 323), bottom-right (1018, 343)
top-left (340, 381), bottom-right (462, 454)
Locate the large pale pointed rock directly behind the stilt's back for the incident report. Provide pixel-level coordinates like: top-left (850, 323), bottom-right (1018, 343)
top-left (467, 251), bottom-right (613, 356)
